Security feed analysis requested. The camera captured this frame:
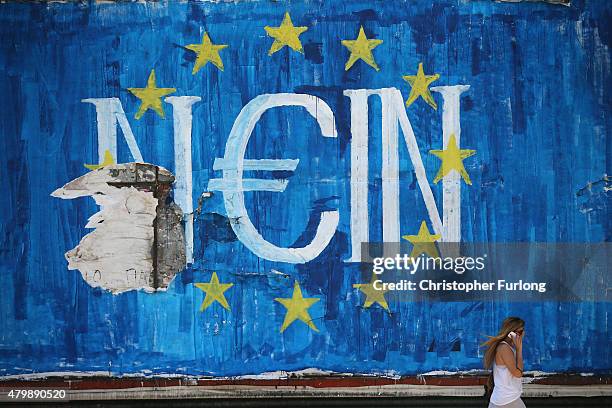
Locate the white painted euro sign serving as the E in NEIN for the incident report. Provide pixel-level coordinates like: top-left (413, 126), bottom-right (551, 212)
top-left (208, 93), bottom-right (340, 264)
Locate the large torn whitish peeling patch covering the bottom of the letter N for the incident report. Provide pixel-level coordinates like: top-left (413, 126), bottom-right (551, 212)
top-left (51, 163), bottom-right (185, 294)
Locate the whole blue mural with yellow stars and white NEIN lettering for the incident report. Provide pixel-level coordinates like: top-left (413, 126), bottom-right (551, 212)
top-left (0, 0), bottom-right (612, 386)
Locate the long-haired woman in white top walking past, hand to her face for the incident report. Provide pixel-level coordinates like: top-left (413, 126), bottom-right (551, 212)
top-left (482, 317), bottom-right (525, 408)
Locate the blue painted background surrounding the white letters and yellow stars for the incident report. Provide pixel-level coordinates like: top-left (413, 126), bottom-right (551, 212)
top-left (0, 0), bottom-right (612, 376)
